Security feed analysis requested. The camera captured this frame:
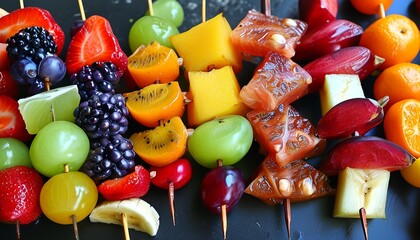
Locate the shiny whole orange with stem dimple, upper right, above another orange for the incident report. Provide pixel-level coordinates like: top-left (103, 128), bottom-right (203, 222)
top-left (360, 14), bottom-right (420, 69)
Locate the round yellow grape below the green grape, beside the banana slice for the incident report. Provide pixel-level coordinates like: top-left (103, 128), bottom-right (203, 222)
top-left (40, 172), bottom-right (98, 224)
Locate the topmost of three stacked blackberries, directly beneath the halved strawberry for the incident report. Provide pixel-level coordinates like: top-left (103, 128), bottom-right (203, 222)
top-left (70, 62), bottom-right (120, 101)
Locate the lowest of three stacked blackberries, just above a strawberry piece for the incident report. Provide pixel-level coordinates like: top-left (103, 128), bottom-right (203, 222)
top-left (81, 135), bottom-right (135, 182)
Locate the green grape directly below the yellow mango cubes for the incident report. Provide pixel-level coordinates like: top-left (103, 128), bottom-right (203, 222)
top-left (188, 115), bottom-right (253, 168)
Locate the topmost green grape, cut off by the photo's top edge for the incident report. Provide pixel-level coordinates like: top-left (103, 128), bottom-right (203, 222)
top-left (145, 0), bottom-right (184, 27)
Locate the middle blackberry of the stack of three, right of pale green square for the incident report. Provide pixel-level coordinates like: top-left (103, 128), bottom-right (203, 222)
top-left (74, 93), bottom-right (129, 139)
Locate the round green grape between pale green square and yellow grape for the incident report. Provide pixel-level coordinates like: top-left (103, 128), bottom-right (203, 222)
top-left (29, 121), bottom-right (90, 177)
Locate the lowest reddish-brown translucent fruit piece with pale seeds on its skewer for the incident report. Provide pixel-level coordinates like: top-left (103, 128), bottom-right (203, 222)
top-left (245, 154), bottom-right (334, 205)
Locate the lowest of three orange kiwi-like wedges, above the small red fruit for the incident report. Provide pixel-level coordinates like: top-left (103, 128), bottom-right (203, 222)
top-left (130, 117), bottom-right (188, 167)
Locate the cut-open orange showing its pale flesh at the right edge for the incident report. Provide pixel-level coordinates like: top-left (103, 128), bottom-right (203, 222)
top-left (384, 99), bottom-right (420, 158)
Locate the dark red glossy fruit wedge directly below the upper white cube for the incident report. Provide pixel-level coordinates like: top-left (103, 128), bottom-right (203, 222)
top-left (317, 97), bottom-right (388, 139)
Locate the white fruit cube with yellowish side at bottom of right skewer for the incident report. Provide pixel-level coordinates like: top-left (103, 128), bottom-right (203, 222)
top-left (333, 168), bottom-right (390, 218)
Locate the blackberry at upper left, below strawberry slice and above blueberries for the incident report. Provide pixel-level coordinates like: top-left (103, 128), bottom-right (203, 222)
top-left (6, 26), bottom-right (57, 64)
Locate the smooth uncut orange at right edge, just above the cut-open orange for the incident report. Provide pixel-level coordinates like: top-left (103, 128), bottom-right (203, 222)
top-left (373, 63), bottom-right (420, 110)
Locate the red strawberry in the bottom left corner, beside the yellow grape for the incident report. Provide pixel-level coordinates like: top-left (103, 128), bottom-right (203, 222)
top-left (0, 166), bottom-right (44, 224)
